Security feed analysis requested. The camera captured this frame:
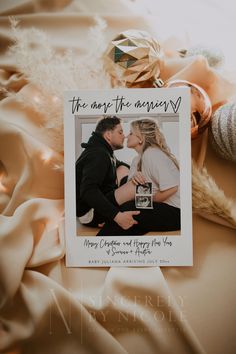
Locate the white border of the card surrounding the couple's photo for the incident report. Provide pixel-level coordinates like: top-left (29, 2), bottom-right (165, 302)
top-left (64, 87), bottom-right (193, 267)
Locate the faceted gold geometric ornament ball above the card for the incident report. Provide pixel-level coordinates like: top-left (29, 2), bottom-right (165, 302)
top-left (104, 30), bottom-right (163, 87)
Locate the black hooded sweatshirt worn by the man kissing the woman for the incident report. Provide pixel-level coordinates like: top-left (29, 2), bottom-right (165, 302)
top-left (76, 132), bottom-right (126, 219)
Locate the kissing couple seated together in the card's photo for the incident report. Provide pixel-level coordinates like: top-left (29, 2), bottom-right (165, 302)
top-left (76, 116), bottom-right (181, 236)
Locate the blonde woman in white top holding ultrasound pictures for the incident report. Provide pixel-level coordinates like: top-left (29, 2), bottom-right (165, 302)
top-left (98, 118), bottom-right (180, 236)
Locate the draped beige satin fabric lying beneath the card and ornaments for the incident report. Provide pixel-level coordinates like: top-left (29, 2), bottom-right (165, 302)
top-left (0, 0), bottom-right (236, 354)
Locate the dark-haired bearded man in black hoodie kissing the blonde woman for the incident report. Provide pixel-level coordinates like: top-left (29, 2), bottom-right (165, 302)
top-left (76, 116), bottom-right (139, 229)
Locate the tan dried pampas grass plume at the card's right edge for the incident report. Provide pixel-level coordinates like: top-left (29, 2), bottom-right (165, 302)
top-left (192, 161), bottom-right (236, 228)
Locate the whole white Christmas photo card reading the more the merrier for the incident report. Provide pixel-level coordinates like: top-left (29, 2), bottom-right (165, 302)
top-left (64, 87), bottom-right (192, 267)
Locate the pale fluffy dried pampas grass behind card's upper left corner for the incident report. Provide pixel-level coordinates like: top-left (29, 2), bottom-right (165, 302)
top-left (7, 17), bottom-right (110, 152)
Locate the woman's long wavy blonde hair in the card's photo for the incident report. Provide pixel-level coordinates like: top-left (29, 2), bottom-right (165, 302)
top-left (131, 118), bottom-right (179, 171)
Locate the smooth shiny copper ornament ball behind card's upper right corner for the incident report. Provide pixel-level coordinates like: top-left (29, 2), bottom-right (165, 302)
top-left (167, 80), bottom-right (212, 139)
